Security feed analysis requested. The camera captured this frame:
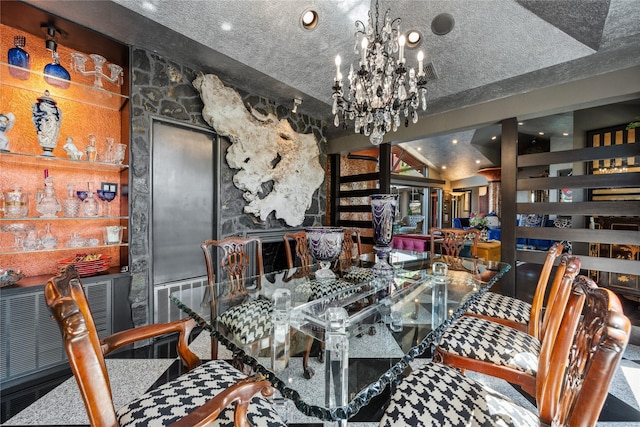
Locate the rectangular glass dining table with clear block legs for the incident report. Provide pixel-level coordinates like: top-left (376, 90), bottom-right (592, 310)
top-left (171, 250), bottom-right (510, 425)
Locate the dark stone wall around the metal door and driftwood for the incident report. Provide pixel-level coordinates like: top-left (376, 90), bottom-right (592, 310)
top-left (129, 48), bottom-right (327, 326)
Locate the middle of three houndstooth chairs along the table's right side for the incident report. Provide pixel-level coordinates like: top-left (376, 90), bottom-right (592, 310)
top-left (433, 255), bottom-right (580, 396)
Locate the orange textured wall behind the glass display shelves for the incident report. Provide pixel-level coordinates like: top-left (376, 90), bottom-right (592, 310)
top-left (0, 25), bottom-right (128, 277)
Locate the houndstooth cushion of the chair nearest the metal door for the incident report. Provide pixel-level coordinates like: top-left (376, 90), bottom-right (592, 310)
top-left (218, 299), bottom-right (273, 344)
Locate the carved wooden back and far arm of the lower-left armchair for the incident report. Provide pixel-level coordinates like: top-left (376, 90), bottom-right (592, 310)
top-left (44, 266), bottom-right (200, 426)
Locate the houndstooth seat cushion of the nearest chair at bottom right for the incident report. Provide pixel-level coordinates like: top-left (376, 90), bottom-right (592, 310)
top-left (380, 362), bottom-right (540, 427)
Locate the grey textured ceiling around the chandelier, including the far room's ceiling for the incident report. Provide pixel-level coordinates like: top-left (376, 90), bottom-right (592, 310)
top-left (18, 0), bottom-right (640, 180)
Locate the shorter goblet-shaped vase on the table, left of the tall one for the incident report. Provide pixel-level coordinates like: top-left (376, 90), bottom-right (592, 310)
top-left (306, 227), bottom-right (344, 279)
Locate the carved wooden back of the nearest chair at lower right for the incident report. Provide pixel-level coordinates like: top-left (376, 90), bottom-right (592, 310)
top-left (536, 276), bottom-right (631, 426)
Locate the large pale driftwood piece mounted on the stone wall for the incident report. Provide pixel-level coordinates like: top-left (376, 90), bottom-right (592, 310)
top-left (193, 74), bottom-right (324, 227)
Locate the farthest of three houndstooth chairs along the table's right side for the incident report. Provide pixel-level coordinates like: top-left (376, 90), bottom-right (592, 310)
top-left (464, 242), bottom-right (564, 339)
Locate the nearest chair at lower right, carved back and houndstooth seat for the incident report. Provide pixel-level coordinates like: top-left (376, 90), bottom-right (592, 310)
top-left (380, 276), bottom-right (631, 427)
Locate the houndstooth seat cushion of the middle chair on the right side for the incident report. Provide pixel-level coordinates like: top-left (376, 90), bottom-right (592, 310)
top-left (438, 316), bottom-right (540, 375)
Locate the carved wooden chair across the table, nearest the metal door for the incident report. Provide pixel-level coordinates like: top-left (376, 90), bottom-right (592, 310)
top-left (200, 236), bottom-right (273, 362)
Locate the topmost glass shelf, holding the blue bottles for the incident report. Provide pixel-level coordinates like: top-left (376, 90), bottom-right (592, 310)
top-left (0, 62), bottom-right (129, 111)
